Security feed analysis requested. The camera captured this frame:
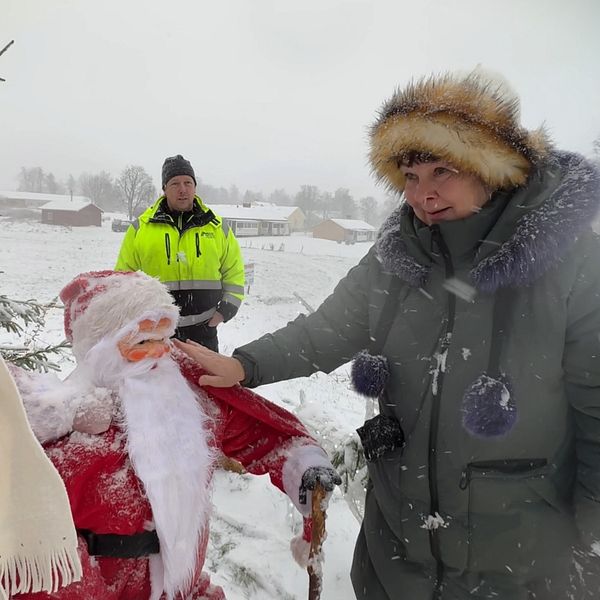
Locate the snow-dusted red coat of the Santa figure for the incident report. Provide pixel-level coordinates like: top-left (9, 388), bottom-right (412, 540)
top-left (15, 356), bottom-right (317, 600)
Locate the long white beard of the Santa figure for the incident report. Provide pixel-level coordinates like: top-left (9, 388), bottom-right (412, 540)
top-left (78, 332), bottom-right (214, 600)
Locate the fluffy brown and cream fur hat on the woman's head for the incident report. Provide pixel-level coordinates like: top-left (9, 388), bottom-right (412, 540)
top-left (370, 71), bottom-right (549, 192)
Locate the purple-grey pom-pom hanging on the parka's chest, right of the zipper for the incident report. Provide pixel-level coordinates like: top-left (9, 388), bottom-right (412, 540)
top-left (462, 375), bottom-right (517, 438)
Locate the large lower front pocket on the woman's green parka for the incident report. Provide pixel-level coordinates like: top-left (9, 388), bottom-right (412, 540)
top-left (460, 458), bottom-right (575, 577)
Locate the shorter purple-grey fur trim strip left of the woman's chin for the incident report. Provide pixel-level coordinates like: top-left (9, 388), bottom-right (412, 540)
top-left (375, 206), bottom-right (429, 288)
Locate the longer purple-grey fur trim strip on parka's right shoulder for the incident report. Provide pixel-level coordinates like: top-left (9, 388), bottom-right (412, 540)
top-left (471, 152), bottom-right (600, 293)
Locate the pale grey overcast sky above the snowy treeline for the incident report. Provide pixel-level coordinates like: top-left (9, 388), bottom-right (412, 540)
top-left (0, 0), bottom-right (600, 199)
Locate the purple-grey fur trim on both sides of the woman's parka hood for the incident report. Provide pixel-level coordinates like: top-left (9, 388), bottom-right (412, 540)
top-left (375, 152), bottom-right (600, 293)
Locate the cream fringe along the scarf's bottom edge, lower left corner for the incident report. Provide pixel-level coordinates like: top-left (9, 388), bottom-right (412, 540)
top-left (0, 547), bottom-right (82, 600)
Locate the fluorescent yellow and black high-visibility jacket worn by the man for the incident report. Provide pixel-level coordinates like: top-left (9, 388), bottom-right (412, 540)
top-left (115, 196), bottom-right (244, 327)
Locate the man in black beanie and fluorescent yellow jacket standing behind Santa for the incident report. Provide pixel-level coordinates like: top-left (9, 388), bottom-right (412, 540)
top-left (115, 154), bottom-right (244, 351)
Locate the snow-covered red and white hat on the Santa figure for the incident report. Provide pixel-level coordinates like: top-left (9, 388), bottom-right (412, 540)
top-left (60, 271), bottom-right (179, 360)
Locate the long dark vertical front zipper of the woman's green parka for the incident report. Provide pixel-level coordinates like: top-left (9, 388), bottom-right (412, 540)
top-left (428, 225), bottom-right (456, 600)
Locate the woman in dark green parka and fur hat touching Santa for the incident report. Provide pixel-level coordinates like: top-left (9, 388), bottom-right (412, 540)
top-left (180, 73), bottom-right (600, 600)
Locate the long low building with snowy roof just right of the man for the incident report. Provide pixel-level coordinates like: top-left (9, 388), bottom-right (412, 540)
top-left (211, 204), bottom-right (304, 237)
